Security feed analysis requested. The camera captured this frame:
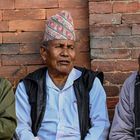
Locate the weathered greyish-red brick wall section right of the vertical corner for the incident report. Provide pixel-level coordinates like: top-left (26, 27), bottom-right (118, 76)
top-left (89, 0), bottom-right (140, 119)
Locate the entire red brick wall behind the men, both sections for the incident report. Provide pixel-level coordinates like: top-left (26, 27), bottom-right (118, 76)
top-left (0, 0), bottom-right (140, 119)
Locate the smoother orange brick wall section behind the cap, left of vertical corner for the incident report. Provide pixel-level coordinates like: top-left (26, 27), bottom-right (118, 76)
top-left (0, 0), bottom-right (90, 86)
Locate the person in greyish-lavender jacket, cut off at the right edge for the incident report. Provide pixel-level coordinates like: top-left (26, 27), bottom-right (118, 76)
top-left (109, 55), bottom-right (140, 140)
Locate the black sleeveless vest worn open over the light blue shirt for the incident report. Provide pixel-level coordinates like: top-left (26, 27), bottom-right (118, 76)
top-left (22, 67), bottom-right (103, 140)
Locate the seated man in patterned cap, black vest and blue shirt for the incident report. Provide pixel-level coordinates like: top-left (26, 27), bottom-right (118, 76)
top-left (16, 11), bottom-right (109, 140)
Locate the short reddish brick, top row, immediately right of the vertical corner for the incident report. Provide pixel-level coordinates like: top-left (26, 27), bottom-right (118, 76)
top-left (89, 2), bottom-right (112, 14)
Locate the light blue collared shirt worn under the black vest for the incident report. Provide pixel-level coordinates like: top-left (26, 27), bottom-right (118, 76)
top-left (16, 68), bottom-right (109, 140)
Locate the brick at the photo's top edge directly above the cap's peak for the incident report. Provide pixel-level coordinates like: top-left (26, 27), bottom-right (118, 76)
top-left (59, 0), bottom-right (88, 8)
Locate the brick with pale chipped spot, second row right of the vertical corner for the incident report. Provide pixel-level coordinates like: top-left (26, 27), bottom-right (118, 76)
top-left (89, 14), bottom-right (121, 25)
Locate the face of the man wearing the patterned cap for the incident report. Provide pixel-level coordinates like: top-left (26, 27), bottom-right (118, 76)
top-left (41, 40), bottom-right (75, 75)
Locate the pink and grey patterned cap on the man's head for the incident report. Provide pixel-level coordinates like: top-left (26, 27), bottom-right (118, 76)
top-left (43, 11), bottom-right (75, 41)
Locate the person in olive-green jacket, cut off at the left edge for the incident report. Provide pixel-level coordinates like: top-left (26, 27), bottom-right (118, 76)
top-left (0, 78), bottom-right (16, 140)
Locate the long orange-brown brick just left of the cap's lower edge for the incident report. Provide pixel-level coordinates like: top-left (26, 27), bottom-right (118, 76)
top-left (3, 32), bottom-right (43, 43)
